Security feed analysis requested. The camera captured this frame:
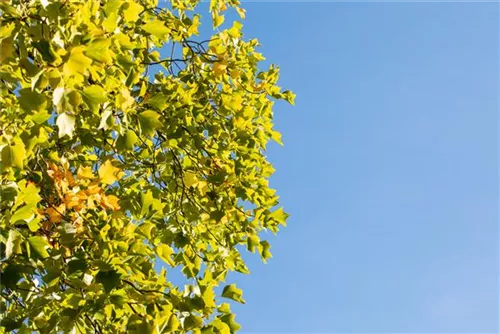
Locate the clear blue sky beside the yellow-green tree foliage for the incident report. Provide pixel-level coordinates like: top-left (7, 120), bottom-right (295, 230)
top-left (205, 1), bottom-right (500, 333)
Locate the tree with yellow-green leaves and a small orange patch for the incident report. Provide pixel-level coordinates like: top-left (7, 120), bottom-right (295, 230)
top-left (0, 0), bottom-right (294, 333)
